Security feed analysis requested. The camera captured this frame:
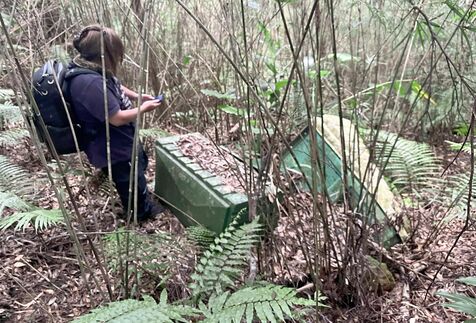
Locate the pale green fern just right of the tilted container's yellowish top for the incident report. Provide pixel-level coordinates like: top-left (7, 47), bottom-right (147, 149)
top-left (375, 132), bottom-right (440, 195)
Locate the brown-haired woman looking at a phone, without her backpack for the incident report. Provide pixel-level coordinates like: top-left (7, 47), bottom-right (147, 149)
top-left (69, 25), bottom-right (163, 221)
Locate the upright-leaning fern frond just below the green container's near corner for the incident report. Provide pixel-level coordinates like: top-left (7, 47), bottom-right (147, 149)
top-left (190, 217), bottom-right (263, 297)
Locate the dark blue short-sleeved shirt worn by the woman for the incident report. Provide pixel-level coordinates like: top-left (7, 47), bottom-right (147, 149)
top-left (69, 74), bottom-right (135, 168)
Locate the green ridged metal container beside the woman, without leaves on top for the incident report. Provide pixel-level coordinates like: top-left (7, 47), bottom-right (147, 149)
top-left (155, 134), bottom-right (248, 233)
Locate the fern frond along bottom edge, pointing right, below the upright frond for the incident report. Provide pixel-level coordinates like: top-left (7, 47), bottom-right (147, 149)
top-left (205, 284), bottom-right (325, 323)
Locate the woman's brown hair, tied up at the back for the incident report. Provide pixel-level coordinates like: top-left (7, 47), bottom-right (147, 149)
top-left (73, 25), bottom-right (124, 74)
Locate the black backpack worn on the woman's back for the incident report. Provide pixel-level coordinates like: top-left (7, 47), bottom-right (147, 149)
top-left (32, 60), bottom-right (99, 155)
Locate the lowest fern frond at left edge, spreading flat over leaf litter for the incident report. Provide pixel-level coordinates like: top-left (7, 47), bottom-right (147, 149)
top-left (0, 208), bottom-right (63, 231)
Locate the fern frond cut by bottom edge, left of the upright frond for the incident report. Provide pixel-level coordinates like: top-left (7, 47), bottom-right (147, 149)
top-left (73, 294), bottom-right (200, 323)
